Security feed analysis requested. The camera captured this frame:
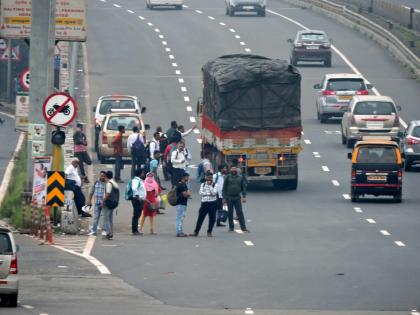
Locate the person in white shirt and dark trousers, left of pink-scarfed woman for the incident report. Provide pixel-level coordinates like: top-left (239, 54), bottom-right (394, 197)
top-left (131, 169), bottom-right (146, 235)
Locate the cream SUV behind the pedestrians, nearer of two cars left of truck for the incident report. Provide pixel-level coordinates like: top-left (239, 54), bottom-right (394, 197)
top-left (98, 110), bottom-right (149, 163)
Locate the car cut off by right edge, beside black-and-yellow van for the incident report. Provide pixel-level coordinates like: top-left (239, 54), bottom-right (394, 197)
top-left (402, 120), bottom-right (420, 172)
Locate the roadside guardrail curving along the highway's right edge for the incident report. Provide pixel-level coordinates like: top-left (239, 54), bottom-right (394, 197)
top-left (284, 0), bottom-right (420, 78)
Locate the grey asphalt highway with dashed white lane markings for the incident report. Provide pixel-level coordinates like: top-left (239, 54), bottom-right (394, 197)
top-left (87, 0), bottom-right (420, 314)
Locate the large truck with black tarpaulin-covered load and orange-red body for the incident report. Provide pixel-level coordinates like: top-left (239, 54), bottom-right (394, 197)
top-left (197, 54), bottom-right (302, 190)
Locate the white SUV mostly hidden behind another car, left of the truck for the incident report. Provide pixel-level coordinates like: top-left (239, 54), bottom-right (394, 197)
top-left (93, 94), bottom-right (143, 152)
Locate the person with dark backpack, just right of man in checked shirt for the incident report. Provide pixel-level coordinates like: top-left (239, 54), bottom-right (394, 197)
top-left (102, 171), bottom-right (120, 240)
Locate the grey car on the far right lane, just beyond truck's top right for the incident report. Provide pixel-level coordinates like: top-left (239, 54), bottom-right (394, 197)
top-left (287, 30), bottom-right (332, 67)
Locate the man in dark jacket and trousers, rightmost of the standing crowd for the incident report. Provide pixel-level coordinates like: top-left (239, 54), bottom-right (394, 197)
top-left (222, 166), bottom-right (249, 232)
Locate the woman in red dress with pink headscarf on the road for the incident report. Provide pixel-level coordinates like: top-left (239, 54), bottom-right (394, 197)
top-left (140, 173), bottom-right (160, 235)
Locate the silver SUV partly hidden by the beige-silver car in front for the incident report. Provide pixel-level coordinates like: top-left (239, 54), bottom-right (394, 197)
top-left (314, 73), bottom-right (373, 123)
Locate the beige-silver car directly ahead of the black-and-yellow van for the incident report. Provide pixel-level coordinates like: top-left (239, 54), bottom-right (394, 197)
top-left (341, 95), bottom-right (401, 148)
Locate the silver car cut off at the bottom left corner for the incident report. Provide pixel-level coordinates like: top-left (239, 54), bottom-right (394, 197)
top-left (0, 226), bottom-right (19, 307)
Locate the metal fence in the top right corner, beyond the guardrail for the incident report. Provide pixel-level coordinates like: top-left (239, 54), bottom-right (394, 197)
top-left (339, 0), bottom-right (420, 32)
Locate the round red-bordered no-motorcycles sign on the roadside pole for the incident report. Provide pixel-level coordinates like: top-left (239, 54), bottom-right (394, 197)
top-left (42, 93), bottom-right (77, 127)
